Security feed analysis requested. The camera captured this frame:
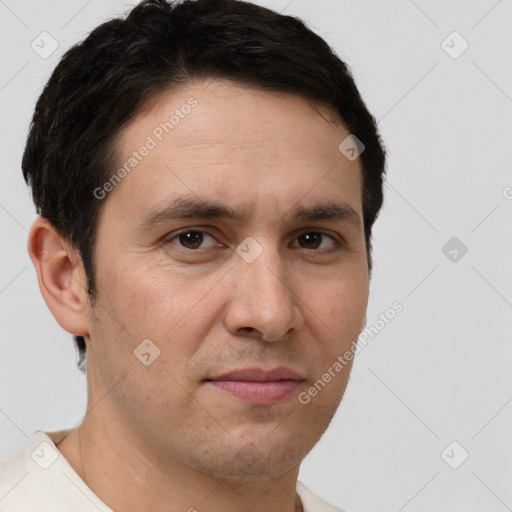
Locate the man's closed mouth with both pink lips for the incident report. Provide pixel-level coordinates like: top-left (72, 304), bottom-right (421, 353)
top-left (205, 366), bottom-right (305, 405)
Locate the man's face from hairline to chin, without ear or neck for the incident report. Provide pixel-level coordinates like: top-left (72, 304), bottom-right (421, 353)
top-left (87, 81), bottom-right (368, 477)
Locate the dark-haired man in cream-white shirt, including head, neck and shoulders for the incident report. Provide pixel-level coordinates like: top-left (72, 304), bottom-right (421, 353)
top-left (0, 0), bottom-right (385, 512)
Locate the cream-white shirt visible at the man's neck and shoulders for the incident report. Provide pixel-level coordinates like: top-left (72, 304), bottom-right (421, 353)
top-left (0, 429), bottom-right (343, 512)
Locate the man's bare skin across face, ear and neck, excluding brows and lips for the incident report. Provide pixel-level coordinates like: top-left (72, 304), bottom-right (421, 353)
top-left (28, 80), bottom-right (368, 512)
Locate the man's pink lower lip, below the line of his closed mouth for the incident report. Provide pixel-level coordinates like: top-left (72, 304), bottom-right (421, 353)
top-left (208, 380), bottom-right (302, 405)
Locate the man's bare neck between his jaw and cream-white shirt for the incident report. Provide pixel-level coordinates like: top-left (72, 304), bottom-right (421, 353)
top-left (57, 411), bottom-right (302, 512)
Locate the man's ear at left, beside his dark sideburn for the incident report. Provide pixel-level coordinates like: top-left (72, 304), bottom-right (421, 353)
top-left (27, 217), bottom-right (89, 336)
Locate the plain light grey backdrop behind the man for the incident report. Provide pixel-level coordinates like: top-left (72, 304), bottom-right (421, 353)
top-left (0, 0), bottom-right (512, 512)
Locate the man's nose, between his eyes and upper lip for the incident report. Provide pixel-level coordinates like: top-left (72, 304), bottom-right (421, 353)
top-left (224, 244), bottom-right (304, 342)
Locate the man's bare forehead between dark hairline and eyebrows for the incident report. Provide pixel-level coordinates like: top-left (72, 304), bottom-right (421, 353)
top-left (108, 80), bottom-right (362, 219)
